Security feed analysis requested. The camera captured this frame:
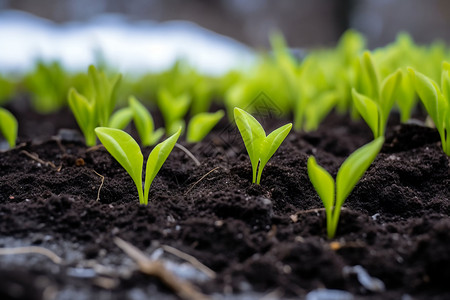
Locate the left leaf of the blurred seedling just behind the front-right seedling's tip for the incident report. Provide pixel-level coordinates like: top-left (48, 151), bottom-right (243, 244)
top-left (352, 89), bottom-right (382, 138)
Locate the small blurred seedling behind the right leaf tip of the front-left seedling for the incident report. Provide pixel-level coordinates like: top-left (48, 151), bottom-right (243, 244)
top-left (158, 88), bottom-right (191, 134)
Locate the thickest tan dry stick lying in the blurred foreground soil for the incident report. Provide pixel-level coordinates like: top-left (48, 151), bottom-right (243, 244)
top-left (114, 237), bottom-right (210, 300)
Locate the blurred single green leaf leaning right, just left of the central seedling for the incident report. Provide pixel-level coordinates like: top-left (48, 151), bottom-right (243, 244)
top-left (186, 110), bottom-right (225, 143)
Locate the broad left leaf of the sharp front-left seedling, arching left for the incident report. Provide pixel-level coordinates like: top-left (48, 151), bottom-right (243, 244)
top-left (95, 127), bottom-right (147, 204)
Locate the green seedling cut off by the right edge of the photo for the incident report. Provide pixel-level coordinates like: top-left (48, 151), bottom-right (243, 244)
top-left (409, 62), bottom-right (450, 156)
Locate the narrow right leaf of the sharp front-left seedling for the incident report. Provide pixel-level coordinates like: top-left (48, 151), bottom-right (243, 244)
top-left (144, 127), bottom-right (182, 204)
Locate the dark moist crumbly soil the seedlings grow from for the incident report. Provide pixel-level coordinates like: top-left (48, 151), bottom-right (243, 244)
top-left (0, 104), bottom-right (450, 300)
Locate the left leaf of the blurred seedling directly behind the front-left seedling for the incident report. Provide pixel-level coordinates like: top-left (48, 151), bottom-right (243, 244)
top-left (69, 88), bottom-right (97, 146)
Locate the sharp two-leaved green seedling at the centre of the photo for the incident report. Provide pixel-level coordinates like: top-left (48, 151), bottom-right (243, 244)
top-left (234, 107), bottom-right (292, 184)
